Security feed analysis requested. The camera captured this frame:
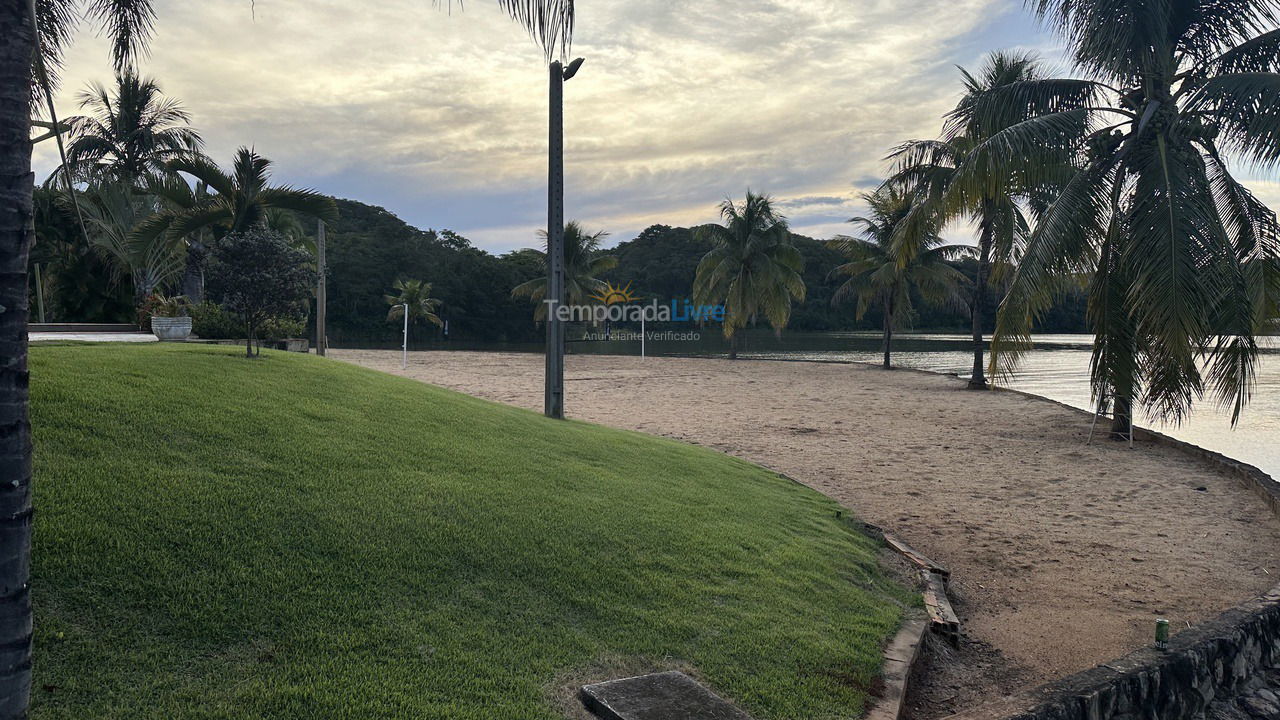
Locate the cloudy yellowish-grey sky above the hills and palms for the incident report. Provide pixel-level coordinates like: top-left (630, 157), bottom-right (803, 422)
top-left (27, 0), bottom-right (1280, 252)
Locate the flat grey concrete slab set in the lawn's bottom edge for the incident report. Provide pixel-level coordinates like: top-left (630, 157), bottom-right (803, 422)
top-left (582, 671), bottom-right (751, 720)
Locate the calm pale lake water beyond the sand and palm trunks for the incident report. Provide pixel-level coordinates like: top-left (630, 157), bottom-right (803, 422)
top-left (568, 332), bottom-right (1280, 478)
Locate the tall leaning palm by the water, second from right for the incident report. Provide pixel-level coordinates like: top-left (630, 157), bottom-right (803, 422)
top-left (888, 53), bottom-right (1041, 389)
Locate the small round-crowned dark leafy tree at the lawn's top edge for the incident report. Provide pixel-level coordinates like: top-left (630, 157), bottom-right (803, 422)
top-left (207, 225), bottom-right (315, 357)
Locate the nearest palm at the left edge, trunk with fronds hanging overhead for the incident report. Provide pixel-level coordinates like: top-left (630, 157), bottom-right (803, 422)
top-left (0, 0), bottom-right (154, 720)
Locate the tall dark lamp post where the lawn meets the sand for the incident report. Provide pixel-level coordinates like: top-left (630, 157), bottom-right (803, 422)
top-left (543, 58), bottom-right (582, 419)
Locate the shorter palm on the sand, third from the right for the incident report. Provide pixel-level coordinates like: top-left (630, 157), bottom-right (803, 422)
top-left (827, 186), bottom-right (972, 369)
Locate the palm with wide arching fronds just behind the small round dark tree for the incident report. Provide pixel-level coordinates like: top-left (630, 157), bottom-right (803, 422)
top-left (137, 147), bottom-right (338, 302)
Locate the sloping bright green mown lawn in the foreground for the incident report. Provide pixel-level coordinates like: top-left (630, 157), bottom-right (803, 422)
top-left (31, 345), bottom-right (911, 720)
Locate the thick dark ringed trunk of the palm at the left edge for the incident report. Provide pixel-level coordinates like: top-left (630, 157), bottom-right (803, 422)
top-left (0, 0), bottom-right (36, 720)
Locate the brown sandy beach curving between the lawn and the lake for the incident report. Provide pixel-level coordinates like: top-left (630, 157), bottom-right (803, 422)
top-left (330, 350), bottom-right (1280, 702)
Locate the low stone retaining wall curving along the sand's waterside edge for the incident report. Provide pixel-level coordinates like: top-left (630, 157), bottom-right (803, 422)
top-left (948, 388), bottom-right (1280, 720)
